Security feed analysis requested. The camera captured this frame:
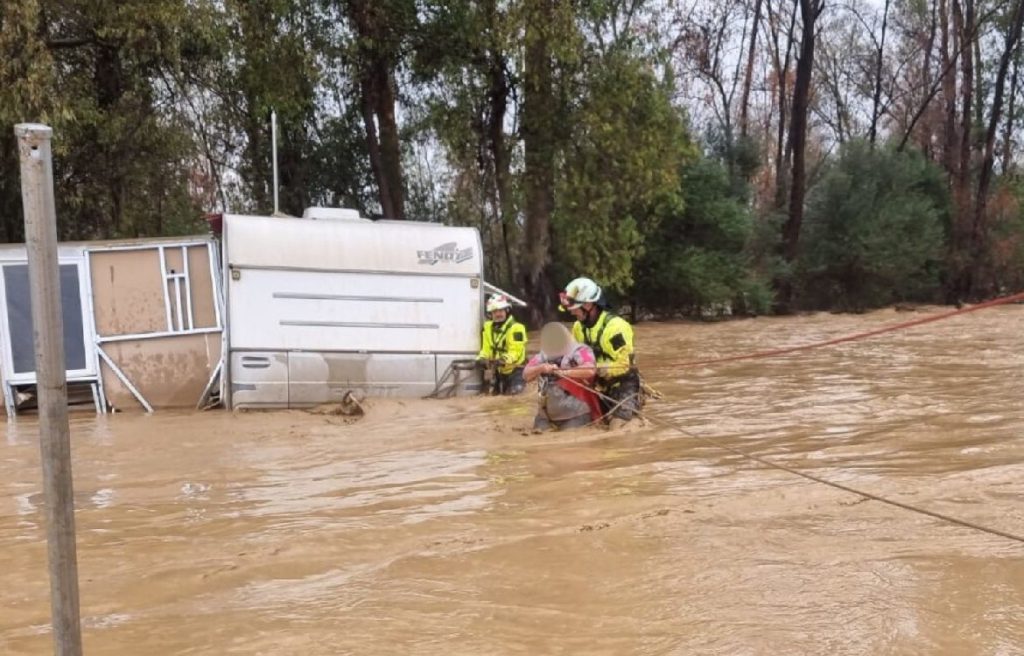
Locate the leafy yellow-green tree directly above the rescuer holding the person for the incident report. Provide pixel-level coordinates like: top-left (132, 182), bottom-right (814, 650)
top-left (553, 49), bottom-right (695, 292)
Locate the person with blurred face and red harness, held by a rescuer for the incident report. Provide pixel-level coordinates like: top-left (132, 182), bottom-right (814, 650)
top-left (523, 323), bottom-right (601, 431)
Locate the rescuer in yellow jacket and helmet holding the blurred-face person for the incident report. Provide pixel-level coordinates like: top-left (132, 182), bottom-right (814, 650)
top-left (560, 277), bottom-right (643, 428)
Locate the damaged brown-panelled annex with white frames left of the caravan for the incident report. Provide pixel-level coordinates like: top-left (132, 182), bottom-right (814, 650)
top-left (0, 236), bottom-right (224, 414)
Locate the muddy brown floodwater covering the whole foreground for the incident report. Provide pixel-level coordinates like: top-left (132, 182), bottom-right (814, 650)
top-left (0, 306), bottom-right (1024, 656)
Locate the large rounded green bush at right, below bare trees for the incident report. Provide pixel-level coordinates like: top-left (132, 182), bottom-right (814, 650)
top-left (794, 142), bottom-right (948, 310)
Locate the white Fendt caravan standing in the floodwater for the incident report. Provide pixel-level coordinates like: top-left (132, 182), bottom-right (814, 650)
top-left (221, 209), bottom-right (484, 408)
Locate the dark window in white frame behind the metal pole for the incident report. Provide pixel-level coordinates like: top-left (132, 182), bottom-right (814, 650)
top-left (3, 264), bottom-right (89, 376)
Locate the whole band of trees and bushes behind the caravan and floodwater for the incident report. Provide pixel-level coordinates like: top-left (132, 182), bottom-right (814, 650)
top-left (0, 0), bottom-right (1024, 319)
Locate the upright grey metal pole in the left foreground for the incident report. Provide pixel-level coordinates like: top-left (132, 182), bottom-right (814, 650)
top-left (14, 124), bottom-right (82, 656)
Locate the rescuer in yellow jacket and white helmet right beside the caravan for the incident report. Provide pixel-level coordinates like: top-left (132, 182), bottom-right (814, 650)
top-left (476, 294), bottom-right (526, 395)
